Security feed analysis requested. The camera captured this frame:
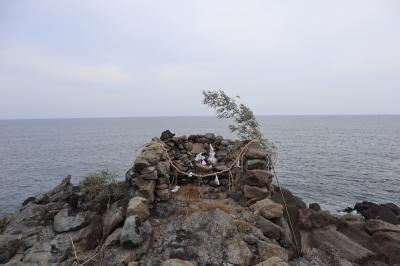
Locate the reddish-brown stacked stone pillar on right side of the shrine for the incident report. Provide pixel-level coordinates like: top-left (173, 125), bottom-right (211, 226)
top-left (241, 148), bottom-right (273, 203)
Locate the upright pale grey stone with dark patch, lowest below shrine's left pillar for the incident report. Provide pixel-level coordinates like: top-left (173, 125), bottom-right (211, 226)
top-left (119, 215), bottom-right (150, 247)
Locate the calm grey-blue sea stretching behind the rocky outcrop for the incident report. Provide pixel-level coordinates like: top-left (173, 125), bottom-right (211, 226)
top-left (0, 116), bottom-right (400, 215)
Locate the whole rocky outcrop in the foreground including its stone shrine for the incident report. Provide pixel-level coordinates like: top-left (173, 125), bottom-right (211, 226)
top-left (0, 131), bottom-right (400, 266)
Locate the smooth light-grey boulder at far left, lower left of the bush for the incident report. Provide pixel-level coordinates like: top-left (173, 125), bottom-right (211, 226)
top-left (53, 209), bottom-right (88, 233)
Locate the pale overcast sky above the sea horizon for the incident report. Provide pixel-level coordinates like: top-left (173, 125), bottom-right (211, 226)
top-left (0, 0), bottom-right (400, 119)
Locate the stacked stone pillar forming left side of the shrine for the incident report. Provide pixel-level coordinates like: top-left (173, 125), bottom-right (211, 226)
top-left (126, 142), bottom-right (170, 203)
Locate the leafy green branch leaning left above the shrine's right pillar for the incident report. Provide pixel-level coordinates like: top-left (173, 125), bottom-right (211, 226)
top-left (203, 90), bottom-right (270, 148)
